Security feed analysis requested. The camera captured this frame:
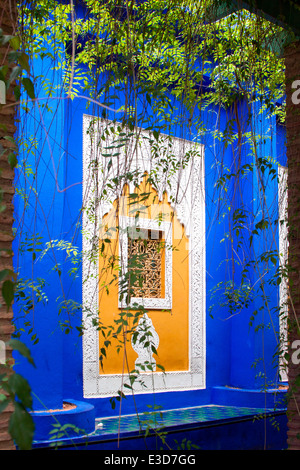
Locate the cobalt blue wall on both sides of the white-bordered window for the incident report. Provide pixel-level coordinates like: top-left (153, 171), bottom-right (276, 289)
top-left (11, 49), bottom-right (283, 415)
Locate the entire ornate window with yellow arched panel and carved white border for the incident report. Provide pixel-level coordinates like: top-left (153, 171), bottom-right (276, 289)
top-left (82, 115), bottom-right (206, 398)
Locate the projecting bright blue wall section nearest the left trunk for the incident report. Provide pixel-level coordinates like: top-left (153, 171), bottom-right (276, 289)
top-left (13, 46), bottom-right (64, 408)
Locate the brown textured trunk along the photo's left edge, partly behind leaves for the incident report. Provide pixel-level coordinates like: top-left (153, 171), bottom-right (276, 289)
top-left (0, 0), bottom-right (16, 450)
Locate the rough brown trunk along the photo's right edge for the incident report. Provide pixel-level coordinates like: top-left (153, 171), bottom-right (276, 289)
top-left (285, 42), bottom-right (300, 450)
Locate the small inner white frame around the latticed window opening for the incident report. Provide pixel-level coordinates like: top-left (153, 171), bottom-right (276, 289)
top-left (119, 216), bottom-right (172, 310)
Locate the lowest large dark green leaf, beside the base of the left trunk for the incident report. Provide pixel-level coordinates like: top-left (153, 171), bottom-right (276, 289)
top-left (8, 402), bottom-right (34, 450)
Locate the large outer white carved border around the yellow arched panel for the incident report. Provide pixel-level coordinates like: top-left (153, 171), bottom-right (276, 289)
top-left (82, 115), bottom-right (206, 398)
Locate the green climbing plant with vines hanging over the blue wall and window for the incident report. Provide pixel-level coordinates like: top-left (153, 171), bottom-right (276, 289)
top-left (0, 0), bottom-right (292, 448)
